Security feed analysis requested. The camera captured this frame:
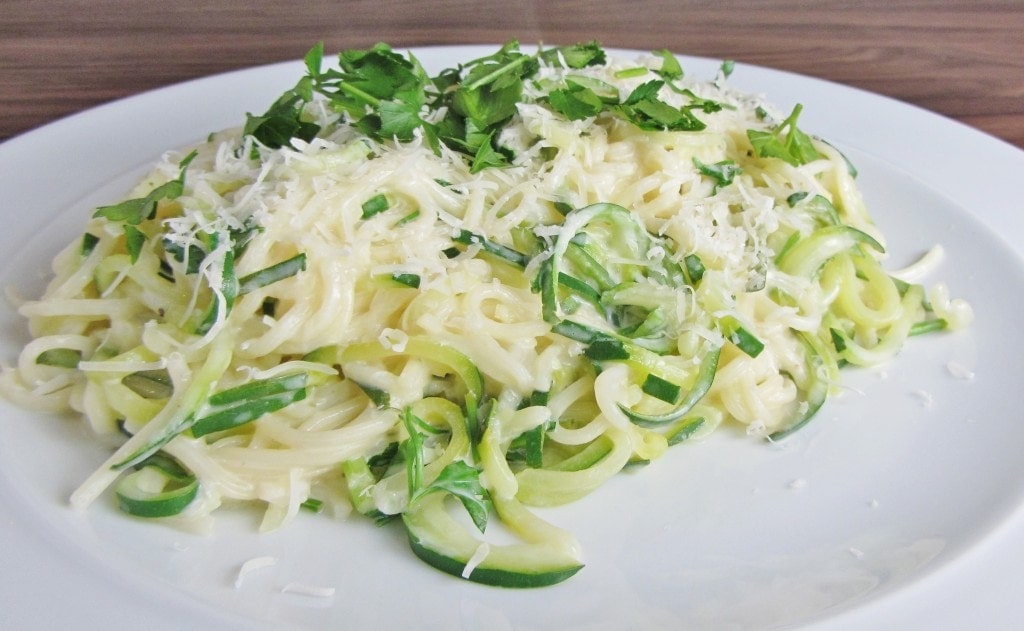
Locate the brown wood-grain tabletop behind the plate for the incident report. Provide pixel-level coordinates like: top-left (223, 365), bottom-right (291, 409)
top-left (0, 0), bottom-right (1024, 148)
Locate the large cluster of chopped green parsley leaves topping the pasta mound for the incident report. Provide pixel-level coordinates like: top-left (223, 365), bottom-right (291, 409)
top-left (245, 40), bottom-right (737, 173)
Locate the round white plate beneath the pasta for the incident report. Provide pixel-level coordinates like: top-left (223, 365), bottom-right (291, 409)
top-left (0, 46), bottom-right (1024, 629)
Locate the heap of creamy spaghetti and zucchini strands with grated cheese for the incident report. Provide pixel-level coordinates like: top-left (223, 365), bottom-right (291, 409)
top-left (0, 41), bottom-right (971, 585)
